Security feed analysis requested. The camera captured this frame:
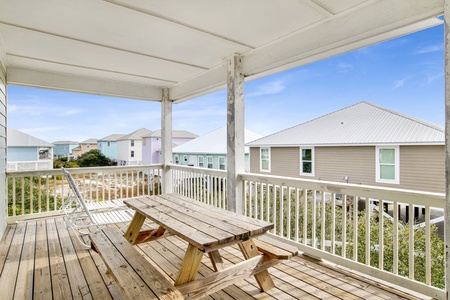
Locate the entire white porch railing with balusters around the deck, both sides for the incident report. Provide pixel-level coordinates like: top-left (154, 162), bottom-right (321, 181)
top-left (8, 165), bottom-right (445, 299)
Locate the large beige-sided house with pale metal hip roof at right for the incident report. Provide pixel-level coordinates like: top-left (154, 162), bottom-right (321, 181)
top-left (247, 102), bottom-right (445, 193)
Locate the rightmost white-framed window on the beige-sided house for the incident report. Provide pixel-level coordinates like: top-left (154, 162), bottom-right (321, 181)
top-left (376, 146), bottom-right (400, 184)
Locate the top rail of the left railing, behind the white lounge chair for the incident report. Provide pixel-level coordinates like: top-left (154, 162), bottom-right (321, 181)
top-left (6, 164), bottom-right (162, 177)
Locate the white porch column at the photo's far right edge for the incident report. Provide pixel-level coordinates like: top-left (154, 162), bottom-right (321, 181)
top-left (444, 0), bottom-right (450, 299)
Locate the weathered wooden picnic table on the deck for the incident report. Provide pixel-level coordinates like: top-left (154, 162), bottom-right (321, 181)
top-left (124, 194), bottom-right (297, 299)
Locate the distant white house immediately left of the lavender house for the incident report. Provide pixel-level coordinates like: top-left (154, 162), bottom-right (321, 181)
top-left (117, 128), bottom-right (152, 166)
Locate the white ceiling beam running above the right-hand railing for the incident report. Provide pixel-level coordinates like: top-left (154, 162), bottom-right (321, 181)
top-left (170, 0), bottom-right (444, 102)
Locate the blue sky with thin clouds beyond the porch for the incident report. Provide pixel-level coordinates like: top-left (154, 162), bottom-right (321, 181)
top-left (7, 25), bottom-right (445, 143)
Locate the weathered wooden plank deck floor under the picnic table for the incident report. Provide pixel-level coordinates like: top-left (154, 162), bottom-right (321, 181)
top-left (0, 218), bottom-right (427, 299)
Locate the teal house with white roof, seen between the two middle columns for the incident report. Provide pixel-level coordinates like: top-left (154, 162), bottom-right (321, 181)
top-left (173, 126), bottom-right (261, 172)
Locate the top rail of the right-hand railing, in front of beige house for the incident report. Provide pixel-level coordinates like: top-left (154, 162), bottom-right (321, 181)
top-left (239, 173), bottom-right (445, 208)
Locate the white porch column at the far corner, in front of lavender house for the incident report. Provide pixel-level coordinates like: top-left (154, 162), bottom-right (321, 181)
top-left (161, 88), bottom-right (173, 193)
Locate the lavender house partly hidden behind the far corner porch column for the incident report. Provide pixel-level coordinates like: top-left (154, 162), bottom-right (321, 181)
top-left (142, 130), bottom-right (198, 164)
